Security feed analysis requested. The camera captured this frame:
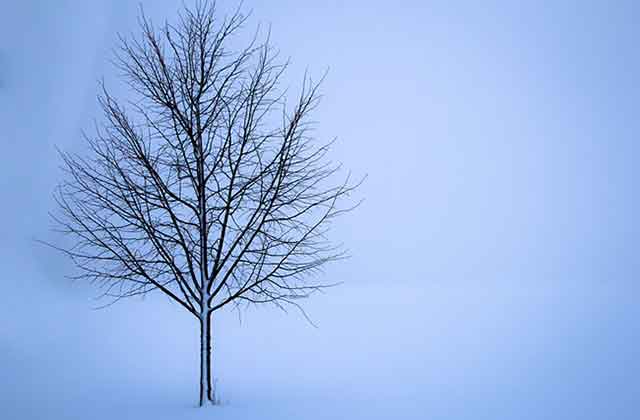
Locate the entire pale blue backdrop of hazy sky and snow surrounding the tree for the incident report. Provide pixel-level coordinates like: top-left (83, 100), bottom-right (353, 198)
top-left (0, 0), bottom-right (640, 420)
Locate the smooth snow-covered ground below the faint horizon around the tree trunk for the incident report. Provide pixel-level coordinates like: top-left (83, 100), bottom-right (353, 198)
top-left (0, 254), bottom-right (640, 420)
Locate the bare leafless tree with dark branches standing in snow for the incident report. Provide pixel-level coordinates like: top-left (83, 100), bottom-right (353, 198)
top-left (53, 2), bottom-right (357, 405)
